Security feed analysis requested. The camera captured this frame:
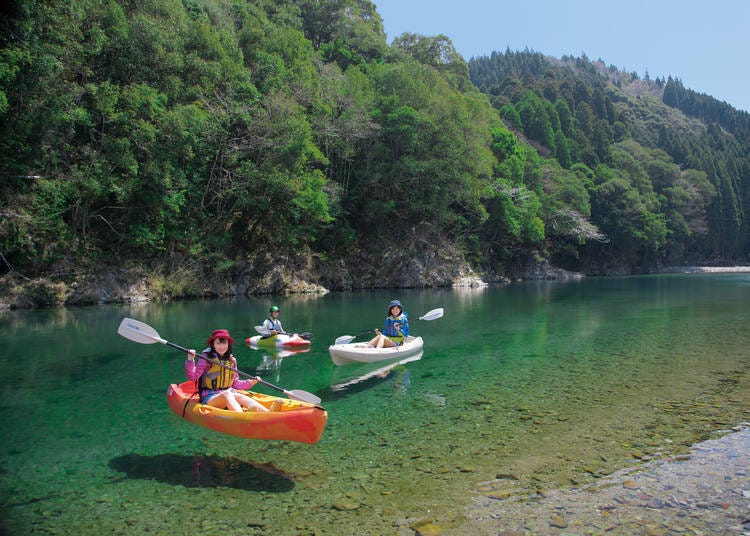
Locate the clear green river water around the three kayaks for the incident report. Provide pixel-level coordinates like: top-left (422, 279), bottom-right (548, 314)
top-left (0, 274), bottom-right (750, 534)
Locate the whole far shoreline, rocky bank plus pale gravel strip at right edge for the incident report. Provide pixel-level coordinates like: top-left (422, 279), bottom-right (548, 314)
top-left (0, 259), bottom-right (750, 311)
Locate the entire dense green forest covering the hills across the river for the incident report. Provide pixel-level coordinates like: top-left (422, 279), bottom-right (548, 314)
top-left (0, 0), bottom-right (750, 302)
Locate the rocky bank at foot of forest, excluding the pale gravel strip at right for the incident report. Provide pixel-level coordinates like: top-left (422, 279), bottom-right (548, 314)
top-left (0, 256), bottom-right (544, 311)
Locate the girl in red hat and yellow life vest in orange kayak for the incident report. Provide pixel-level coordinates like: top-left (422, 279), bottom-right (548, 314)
top-left (185, 329), bottom-right (274, 411)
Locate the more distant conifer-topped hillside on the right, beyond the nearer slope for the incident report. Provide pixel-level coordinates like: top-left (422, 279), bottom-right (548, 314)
top-left (469, 51), bottom-right (750, 271)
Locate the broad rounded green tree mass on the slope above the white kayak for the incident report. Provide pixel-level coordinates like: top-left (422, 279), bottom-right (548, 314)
top-left (336, 62), bottom-right (500, 248)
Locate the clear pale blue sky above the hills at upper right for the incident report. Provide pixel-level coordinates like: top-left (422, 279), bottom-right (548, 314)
top-left (373, 0), bottom-right (750, 111)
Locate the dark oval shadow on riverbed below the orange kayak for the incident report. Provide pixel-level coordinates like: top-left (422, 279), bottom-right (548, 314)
top-left (109, 454), bottom-right (294, 493)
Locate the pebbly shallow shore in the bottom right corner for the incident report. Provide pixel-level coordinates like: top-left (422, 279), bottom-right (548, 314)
top-left (456, 423), bottom-right (750, 536)
